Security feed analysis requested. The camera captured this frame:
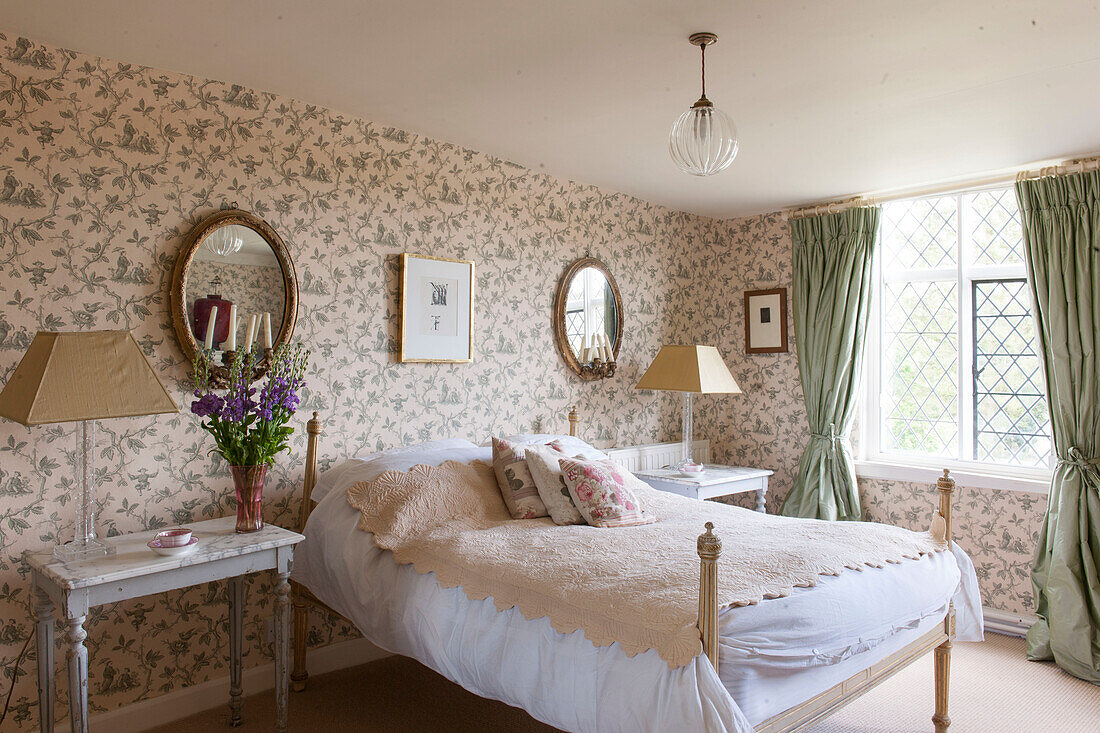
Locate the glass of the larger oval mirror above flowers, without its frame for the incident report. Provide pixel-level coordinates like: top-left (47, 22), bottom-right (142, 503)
top-left (184, 223), bottom-right (286, 352)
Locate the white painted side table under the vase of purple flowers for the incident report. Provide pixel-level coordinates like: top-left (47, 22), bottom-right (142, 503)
top-left (26, 516), bottom-right (304, 733)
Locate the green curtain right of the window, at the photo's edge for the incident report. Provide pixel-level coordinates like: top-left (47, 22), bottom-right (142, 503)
top-left (1016, 172), bottom-right (1100, 683)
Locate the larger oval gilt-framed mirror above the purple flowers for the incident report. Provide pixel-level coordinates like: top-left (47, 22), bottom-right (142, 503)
top-left (171, 209), bottom-right (298, 381)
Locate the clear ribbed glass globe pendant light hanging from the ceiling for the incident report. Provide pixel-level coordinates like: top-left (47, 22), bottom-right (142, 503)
top-left (669, 33), bottom-right (739, 176)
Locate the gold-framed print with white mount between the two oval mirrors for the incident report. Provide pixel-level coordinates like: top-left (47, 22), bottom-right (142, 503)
top-left (398, 253), bottom-right (474, 363)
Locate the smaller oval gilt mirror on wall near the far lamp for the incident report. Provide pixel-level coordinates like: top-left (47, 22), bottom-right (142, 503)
top-left (553, 258), bottom-right (623, 381)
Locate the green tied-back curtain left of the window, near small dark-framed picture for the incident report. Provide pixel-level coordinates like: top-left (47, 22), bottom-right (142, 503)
top-left (780, 207), bottom-right (880, 521)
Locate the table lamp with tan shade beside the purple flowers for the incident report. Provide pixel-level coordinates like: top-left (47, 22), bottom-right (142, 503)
top-left (0, 331), bottom-right (179, 562)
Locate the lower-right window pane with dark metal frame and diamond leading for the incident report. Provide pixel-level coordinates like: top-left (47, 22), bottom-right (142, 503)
top-left (974, 278), bottom-right (1051, 466)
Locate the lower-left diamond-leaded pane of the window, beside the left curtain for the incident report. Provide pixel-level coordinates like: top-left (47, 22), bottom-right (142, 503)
top-left (881, 281), bottom-right (958, 457)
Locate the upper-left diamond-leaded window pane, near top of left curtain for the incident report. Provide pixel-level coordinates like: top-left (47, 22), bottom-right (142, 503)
top-left (882, 196), bottom-right (958, 271)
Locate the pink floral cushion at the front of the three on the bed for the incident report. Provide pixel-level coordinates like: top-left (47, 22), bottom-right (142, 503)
top-left (558, 458), bottom-right (657, 527)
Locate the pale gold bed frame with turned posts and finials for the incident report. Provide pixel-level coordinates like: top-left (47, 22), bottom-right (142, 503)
top-left (290, 407), bottom-right (955, 733)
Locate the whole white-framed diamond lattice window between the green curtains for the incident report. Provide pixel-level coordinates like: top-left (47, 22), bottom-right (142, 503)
top-left (860, 187), bottom-right (1052, 469)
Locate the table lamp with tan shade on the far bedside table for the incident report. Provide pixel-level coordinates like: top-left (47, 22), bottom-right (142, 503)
top-left (634, 346), bottom-right (741, 469)
